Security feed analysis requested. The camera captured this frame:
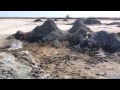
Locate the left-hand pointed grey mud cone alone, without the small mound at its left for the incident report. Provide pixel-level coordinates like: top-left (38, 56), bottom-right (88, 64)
top-left (31, 19), bottom-right (64, 42)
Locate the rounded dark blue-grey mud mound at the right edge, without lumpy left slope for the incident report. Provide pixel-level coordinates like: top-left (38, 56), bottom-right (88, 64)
top-left (90, 31), bottom-right (120, 53)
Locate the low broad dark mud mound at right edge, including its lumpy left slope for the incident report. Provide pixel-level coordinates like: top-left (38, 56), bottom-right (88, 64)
top-left (81, 31), bottom-right (120, 53)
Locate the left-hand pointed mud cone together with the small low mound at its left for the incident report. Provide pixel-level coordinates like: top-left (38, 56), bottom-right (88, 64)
top-left (8, 19), bottom-right (68, 43)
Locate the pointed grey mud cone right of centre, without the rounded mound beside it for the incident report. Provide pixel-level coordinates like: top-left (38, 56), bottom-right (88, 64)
top-left (69, 19), bottom-right (93, 46)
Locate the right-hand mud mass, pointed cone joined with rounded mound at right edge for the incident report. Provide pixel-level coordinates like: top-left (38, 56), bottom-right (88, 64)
top-left (69, 20), bottom-right (120, 53)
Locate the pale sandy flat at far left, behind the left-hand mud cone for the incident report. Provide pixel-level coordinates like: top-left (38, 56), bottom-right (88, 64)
top-left (0, 19), bottom-right (42, 38)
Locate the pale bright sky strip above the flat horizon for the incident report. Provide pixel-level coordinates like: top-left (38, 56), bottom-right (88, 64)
top-left (0, 11), bottom-right (120, 17)
